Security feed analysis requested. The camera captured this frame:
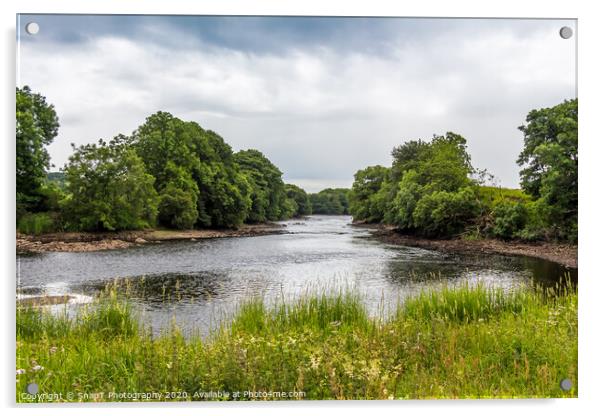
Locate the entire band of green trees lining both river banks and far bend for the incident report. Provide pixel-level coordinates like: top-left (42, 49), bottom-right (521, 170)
top-left (16, 87), bottom-right (578, 242)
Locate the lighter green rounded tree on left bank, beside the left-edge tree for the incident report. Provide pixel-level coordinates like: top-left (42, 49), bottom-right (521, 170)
top-left (64, 136), bottom-right (159, 231)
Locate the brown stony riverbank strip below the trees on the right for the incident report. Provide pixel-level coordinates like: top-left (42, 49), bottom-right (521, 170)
top-left (356, 224), bottom-right (578, 268)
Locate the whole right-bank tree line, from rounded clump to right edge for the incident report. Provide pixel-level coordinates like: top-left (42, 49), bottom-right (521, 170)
top-left (349, 99), bottom-right (578, 242)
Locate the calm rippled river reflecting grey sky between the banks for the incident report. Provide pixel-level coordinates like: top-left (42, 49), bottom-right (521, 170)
top-left (17, 216), bottom-right (576, 333)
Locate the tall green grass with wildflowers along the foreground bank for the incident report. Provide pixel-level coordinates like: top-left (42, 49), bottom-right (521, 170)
top-left (17, 285), bottom-right (577, 402)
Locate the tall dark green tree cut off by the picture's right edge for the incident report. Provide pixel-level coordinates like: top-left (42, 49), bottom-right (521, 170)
top-left (518, 99), bottom-right (578, 241)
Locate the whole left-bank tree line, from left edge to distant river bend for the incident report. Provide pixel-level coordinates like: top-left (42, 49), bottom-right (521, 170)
top-left (16, 87), bottom-right (348, 233)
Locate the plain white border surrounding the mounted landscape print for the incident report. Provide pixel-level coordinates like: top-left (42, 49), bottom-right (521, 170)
top-left (0, 0), bottom-right (602, 416)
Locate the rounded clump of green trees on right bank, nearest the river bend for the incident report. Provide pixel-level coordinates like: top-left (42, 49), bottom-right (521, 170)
top-left (350, 133), bottom-right (479, 236)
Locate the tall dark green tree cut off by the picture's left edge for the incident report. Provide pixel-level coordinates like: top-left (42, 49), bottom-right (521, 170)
top-left (16, 86), bottom-right (59, 219)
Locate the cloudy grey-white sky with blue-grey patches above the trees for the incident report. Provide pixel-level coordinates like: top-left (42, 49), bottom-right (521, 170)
top-left (17, 15), bottom-right (576, 192)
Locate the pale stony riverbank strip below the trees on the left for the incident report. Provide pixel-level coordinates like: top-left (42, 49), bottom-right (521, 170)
top-left (17, 223), bottom-right (286, 253)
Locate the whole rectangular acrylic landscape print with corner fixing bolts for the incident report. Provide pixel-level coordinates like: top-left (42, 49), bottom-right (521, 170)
top-left (15, 14), bottom-right (578, 403)
